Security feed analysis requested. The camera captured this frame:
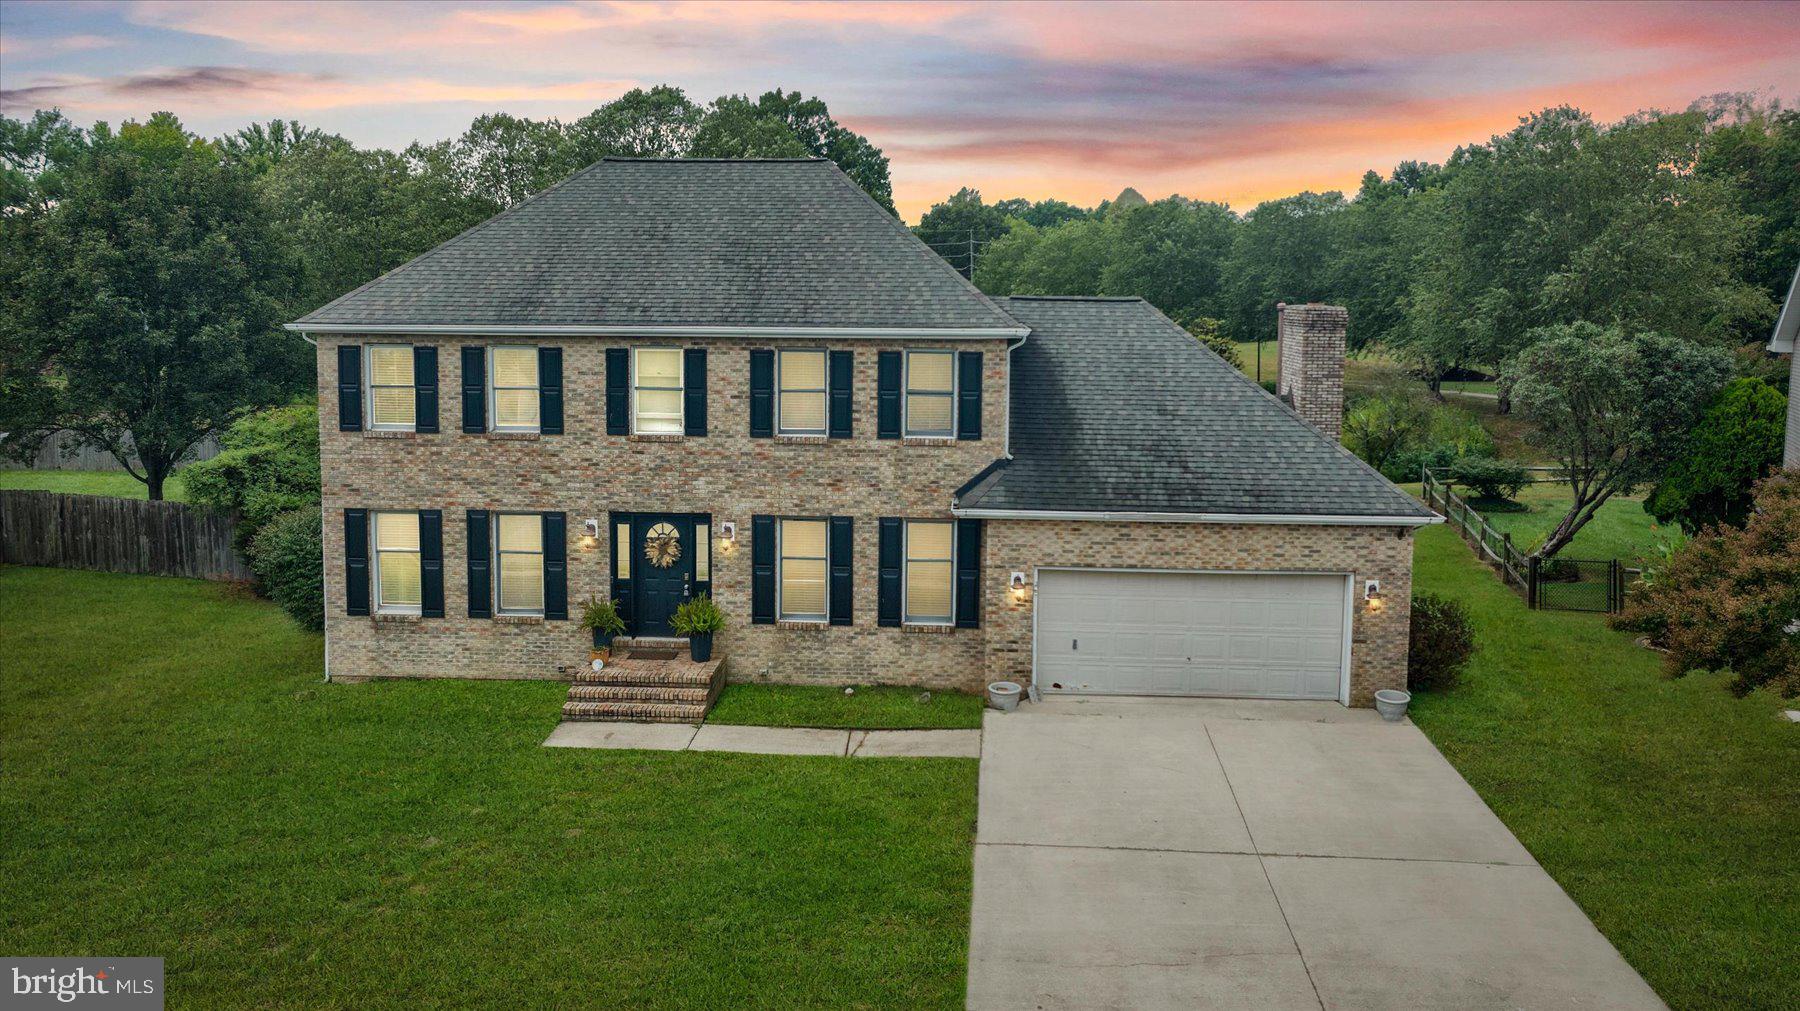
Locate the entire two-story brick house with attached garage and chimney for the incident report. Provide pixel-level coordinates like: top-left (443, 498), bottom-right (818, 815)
top-left (290, 160), bottom-right (1435, 705)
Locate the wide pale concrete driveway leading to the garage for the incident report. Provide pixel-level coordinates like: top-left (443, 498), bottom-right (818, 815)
top-left (968, 698), bottom-right (1663, 1009)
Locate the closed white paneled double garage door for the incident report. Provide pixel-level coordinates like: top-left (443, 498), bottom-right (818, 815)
top-left (1035, 570), bottom-right (1346, 698)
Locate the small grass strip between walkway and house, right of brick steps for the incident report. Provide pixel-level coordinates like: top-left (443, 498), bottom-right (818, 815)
top-left (706, 685), bottom-right (983, 730)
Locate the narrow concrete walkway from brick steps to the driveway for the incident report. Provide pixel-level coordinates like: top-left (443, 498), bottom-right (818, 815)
top-left (544, 721), bottom-right (981, 757)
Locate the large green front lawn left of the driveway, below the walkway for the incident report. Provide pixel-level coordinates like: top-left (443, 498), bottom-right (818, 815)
top-left (0, 568), bottom-right (976, 1007)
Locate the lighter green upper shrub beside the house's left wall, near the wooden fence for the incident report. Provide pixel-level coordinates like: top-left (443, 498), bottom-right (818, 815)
top-left (182, 403), bottom-right (319, 549)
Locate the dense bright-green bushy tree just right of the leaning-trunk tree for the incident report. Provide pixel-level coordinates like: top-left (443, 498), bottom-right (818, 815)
top-left (1643, 378), bottom-right (1787, 534)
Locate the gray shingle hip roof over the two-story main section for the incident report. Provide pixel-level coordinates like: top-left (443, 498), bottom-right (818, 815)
top-left (299, 158), bottom-right (1019, 329)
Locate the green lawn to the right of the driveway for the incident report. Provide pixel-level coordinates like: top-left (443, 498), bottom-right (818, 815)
top-left (1413, 525), bottom-right (1800, 1007)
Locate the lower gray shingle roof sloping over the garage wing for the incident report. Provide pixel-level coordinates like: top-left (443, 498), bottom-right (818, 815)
top-left (958, 297), bottom-right (1431, 520)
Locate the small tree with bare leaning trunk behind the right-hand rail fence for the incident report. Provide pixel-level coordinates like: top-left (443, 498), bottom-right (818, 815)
top-left (1503, 322), bottom-right (1732, 558)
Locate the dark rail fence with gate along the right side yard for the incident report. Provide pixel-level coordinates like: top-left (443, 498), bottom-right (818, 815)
top-left (1422, 468), bottom-right (1636, 613)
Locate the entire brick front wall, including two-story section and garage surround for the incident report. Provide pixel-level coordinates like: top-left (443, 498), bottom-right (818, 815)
top-left (319, 329), bottom-right (1413, 705)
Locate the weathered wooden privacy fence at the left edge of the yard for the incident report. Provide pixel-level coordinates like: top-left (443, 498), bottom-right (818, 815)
top-left (0, 491), bottom-right (250, 579)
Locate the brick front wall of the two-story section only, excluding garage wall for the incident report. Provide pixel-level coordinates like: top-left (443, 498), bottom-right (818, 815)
top-left (319, 336), bottom-right (1008, 689)
